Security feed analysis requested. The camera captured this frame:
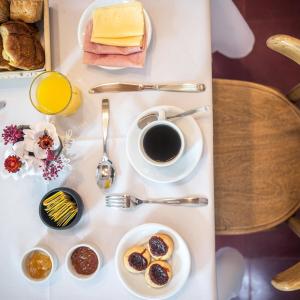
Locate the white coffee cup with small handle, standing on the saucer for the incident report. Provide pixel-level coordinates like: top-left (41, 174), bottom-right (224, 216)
top-left (138, 109), bottom-right (185, 167)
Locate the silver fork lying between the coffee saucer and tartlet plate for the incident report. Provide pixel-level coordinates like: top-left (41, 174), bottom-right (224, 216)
top-left (105, 194), bottom-right (208, 208)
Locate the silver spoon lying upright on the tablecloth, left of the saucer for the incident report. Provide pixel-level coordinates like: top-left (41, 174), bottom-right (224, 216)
top-left (96, 99), bottom-right (115, 190)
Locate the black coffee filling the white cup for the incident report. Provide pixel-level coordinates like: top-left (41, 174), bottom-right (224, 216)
top-left (143, 125), bottom-right (181, 162)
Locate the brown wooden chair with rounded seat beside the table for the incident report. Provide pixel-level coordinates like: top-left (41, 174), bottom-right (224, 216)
top-left (213, 35), bottom-right (300, 290)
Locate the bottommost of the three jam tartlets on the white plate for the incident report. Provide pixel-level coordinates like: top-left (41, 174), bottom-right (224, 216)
top-left (145, 260), bottom-right (172, 288)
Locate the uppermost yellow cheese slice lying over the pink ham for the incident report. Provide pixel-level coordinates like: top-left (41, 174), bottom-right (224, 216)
top-left (92, 1), bottom-right (144, 41)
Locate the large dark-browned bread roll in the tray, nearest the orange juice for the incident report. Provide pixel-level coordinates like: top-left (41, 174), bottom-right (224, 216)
top-left (0, 21), bottom-right (45, 70)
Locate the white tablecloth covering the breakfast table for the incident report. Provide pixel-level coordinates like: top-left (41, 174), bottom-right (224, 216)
top-left (0, 0), bottom-right (217, 300)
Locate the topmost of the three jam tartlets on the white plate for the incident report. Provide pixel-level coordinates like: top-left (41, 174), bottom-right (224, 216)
top-left (148, 233), bottom-right (174, 260)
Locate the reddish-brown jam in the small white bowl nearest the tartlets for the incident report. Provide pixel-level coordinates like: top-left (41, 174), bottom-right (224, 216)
top-left (71, 247), bottom-right (98, 275)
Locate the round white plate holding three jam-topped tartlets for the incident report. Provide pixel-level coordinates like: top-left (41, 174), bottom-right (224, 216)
top-left (115, 223), bottom-right (191, 299)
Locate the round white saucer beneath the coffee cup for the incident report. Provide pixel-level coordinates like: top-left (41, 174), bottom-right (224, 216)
top-left (126, 106), bottom-right (203, 183)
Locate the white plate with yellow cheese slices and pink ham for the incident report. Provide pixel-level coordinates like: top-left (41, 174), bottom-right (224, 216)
top-left (77, 0), bottom-right (152, 70)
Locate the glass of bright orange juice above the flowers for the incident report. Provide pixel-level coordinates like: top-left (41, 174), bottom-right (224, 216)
top-left (29, 71), bottom-right (81, 116)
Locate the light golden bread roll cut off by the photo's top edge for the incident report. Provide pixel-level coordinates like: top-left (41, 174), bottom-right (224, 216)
top-left (10, 0), bottom-right (43, 23)
